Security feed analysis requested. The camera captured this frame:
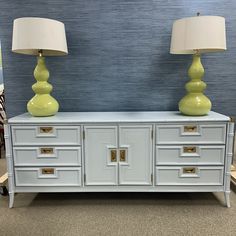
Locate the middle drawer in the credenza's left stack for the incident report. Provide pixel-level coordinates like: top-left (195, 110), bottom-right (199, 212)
top-left (13, 147), bottom-right (81, 166)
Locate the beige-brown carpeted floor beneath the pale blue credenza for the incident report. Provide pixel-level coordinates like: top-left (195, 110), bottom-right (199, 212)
top-left (0, 156), bottom-right (236, 236)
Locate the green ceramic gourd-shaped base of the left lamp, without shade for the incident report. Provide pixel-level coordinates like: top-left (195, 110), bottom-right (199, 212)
top-left (27, 56), bottom-right (59, 116)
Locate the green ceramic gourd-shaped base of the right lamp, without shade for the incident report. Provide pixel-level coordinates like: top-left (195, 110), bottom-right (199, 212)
top-left (179, 54), bottom-right (211, 116)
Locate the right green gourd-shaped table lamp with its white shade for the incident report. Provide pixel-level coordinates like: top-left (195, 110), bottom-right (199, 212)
top-left (170, 13), bottom-right (226, 116)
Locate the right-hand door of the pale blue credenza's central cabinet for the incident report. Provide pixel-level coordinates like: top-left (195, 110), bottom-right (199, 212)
top-left (119, 125), bottom-right (152, 185)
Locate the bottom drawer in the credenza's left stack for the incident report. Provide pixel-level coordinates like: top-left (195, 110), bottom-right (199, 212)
top-left (15, 167), bottom-right (81, 186)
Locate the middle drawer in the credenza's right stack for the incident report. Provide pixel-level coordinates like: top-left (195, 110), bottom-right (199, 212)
top-left (156, 145), bottom-right (225, 165)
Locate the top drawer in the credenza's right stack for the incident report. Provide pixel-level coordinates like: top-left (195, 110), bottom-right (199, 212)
top-left (156, 124), bottom-right (226, 144)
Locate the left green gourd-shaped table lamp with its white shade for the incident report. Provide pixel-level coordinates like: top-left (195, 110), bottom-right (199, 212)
top-left (12, 17), bottom-right (68, 116)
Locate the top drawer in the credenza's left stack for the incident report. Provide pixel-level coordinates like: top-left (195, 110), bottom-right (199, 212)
top-left (12, 125), bottom-right (81, 146)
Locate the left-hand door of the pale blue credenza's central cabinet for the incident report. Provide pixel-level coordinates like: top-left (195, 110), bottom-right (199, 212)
top-left (84, 126), bottom-right (118, 185)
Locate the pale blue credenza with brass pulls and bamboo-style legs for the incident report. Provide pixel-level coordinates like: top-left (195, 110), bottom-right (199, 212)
top-left (5, 111), bottom-right (234, 207)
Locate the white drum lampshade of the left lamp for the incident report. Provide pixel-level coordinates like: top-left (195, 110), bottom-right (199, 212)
top-left (12, 17), bottom-right (68, 56)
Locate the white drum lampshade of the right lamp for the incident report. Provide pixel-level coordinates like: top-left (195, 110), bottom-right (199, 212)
top-left (170, 16), bottom-right (226, 54)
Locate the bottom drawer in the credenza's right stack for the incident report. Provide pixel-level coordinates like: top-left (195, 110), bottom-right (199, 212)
top-left (155, 166), bottom-right (224, 186)
